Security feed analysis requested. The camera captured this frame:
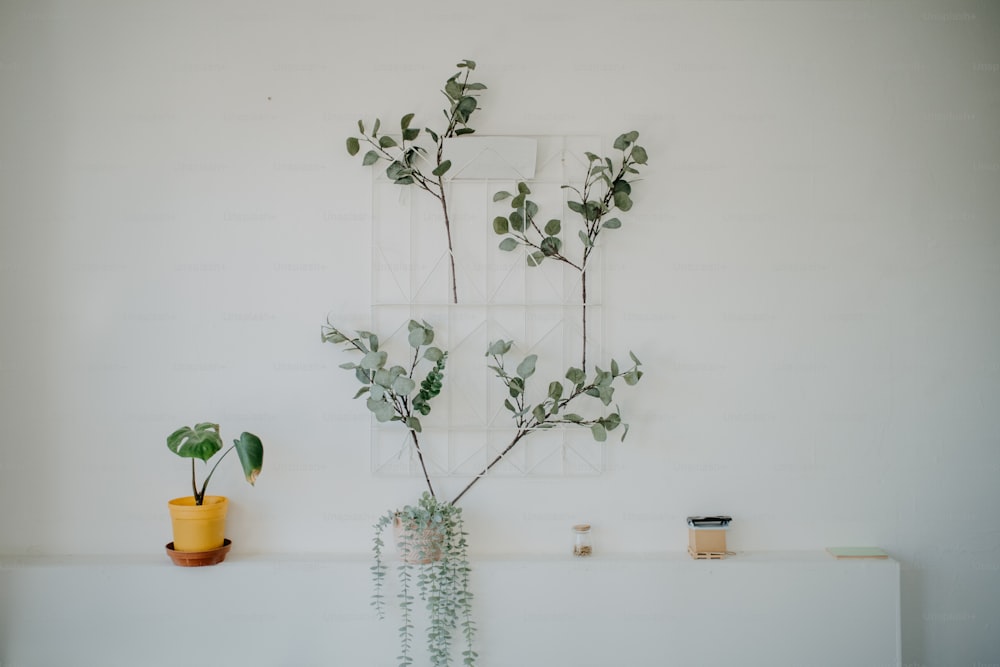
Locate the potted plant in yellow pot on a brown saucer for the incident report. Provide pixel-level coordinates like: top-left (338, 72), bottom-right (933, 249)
top-left (167, 422), bottom-right (264, 565)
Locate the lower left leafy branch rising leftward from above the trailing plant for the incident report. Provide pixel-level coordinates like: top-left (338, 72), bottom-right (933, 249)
top-left (322, 320), bottom-right (448, 497)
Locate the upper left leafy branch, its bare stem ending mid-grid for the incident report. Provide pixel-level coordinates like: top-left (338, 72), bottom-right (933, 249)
top-left (347, 60), bottom-right (486, 303)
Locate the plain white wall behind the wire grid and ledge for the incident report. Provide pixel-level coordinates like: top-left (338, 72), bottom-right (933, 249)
top-left (0, 0), bottom-right (1000, 665)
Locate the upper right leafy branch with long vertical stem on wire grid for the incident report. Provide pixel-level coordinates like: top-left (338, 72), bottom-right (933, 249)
top-left (493, 130), bottom-right (648, 371)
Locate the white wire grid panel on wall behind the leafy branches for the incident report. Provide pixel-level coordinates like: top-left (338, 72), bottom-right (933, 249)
top-left (371, 136), bottom-right (606, 477)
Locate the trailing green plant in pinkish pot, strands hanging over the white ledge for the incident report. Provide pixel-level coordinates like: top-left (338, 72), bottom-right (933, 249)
top-left (371, 492), bottom-right (478, 666)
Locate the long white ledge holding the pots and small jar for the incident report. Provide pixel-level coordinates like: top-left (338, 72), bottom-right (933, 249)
top-left (0, 551), bottom-right (900, 667)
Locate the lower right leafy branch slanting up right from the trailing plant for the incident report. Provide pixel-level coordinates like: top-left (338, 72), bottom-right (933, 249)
top-left (451, 339), bottom-right (643, 505)
